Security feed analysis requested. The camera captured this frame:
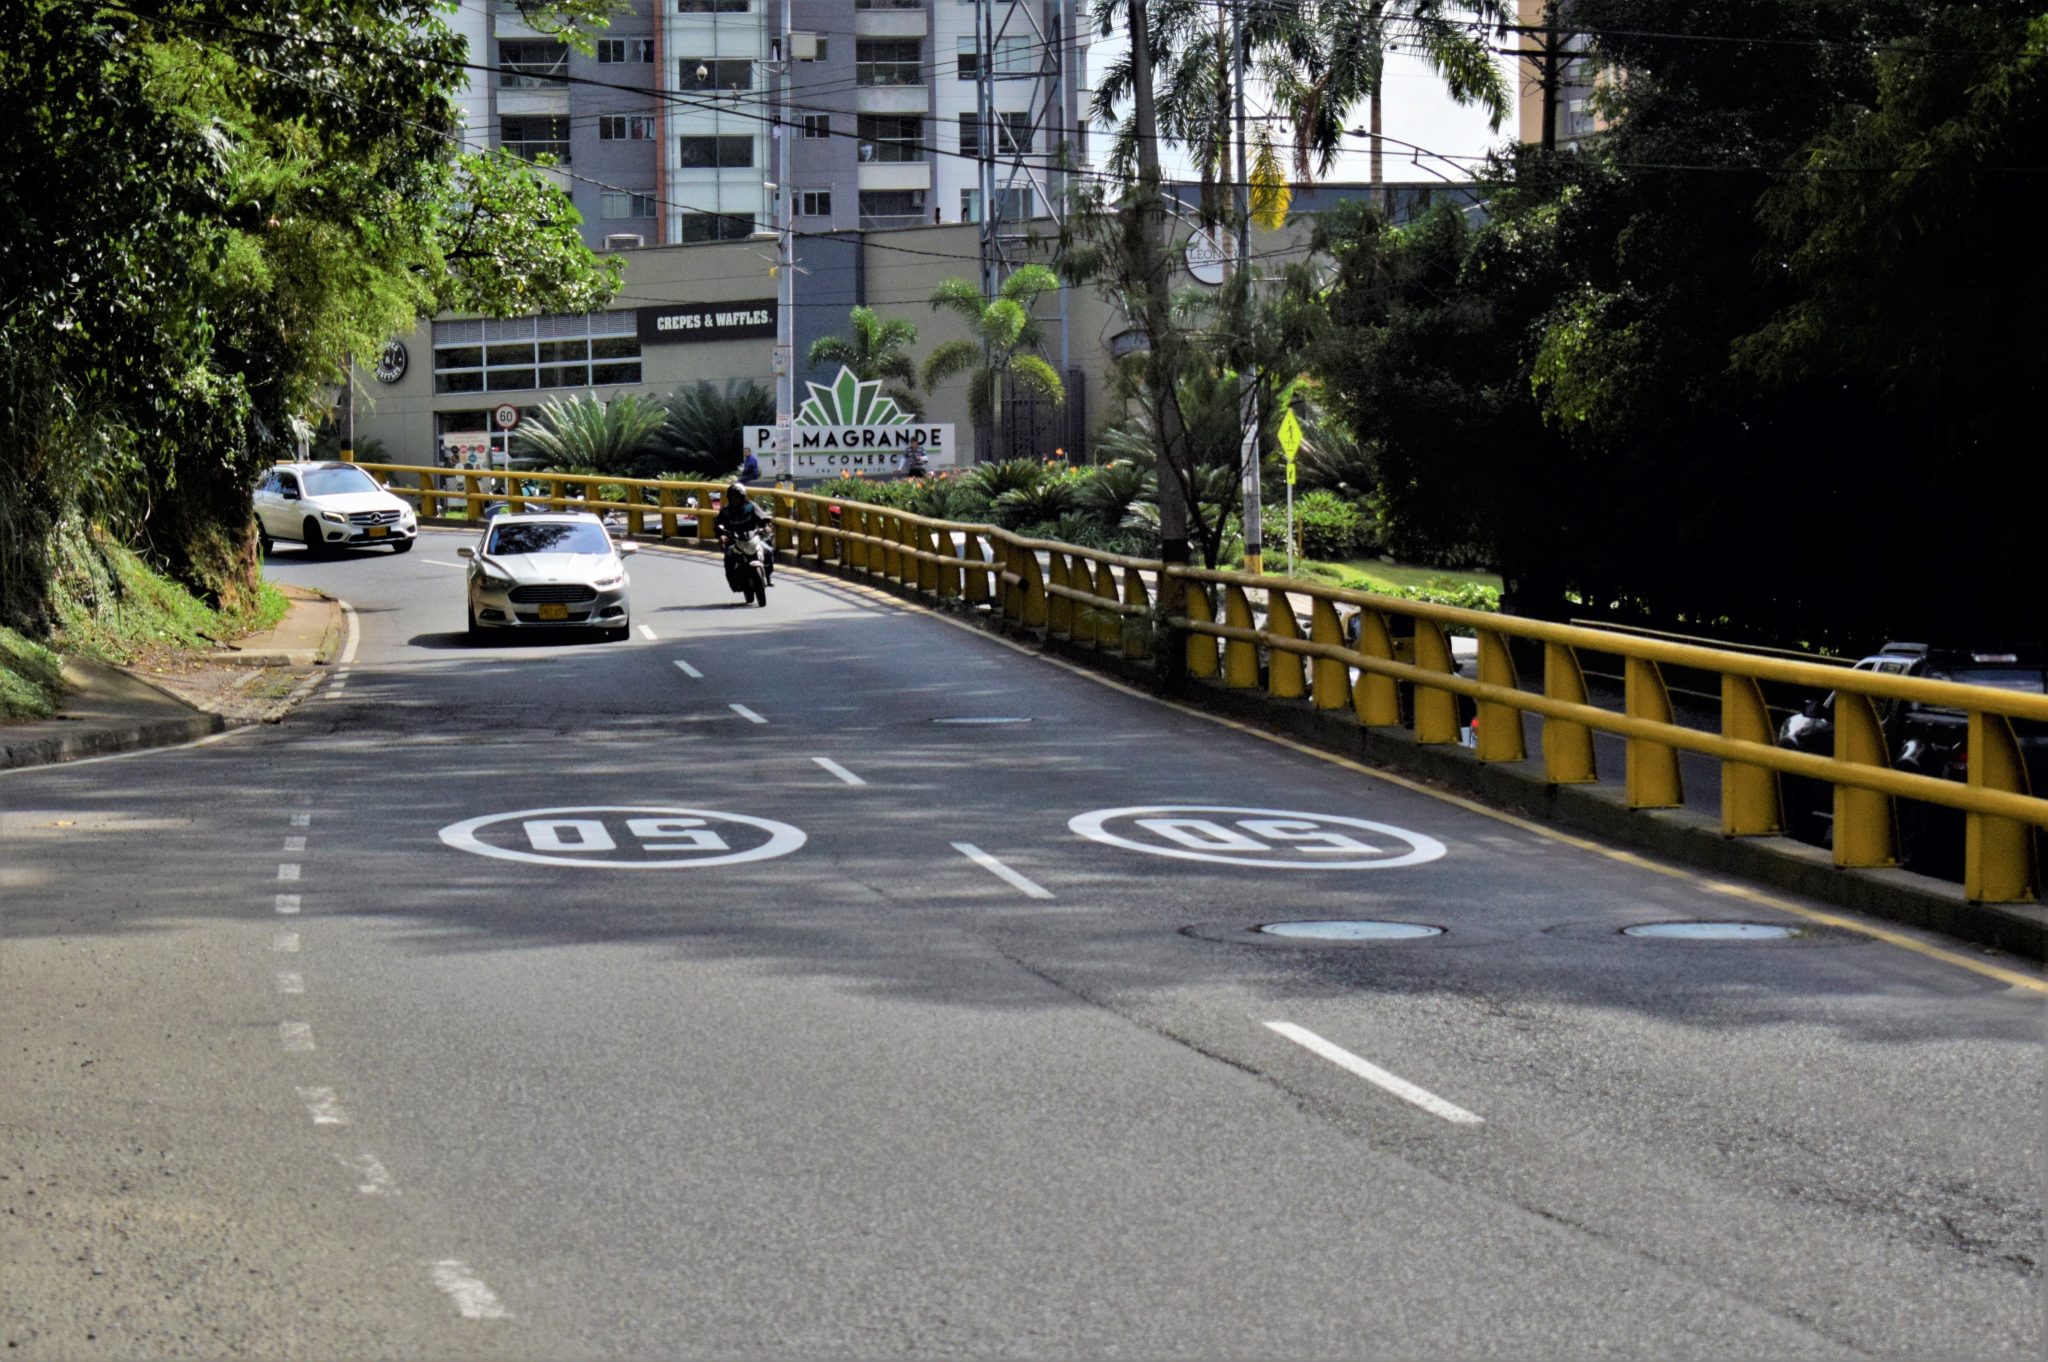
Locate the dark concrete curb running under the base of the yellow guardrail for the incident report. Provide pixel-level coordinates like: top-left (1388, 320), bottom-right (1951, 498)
top-left (662, 545), bottom-right (2048, 963)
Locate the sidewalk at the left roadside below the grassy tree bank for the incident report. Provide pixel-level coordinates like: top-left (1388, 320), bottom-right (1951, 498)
top-left (0, 588), bottom-right (342, 770)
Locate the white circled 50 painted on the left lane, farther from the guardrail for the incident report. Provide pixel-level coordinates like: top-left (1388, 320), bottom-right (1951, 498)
top-left (440, 805), bottom-right (805, 870)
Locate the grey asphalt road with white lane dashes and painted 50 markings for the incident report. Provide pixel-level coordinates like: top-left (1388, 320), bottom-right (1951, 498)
top-left (0, 533), bottom-right (2044, 1358)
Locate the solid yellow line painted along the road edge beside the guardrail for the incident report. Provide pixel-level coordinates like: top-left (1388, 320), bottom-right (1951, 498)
top-left (655, 548), bottom-right (2048, 995)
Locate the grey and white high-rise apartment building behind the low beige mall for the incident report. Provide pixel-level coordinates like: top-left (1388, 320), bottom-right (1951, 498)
top-left (451, 0), bottom-right (1085, 250)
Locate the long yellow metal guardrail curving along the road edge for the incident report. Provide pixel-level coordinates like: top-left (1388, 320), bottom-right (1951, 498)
top-left (360, 463), bottom-right (2048, 903)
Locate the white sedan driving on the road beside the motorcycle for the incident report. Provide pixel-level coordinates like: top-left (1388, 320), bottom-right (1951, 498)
top-left (457, 510), bottom-right (639, 643)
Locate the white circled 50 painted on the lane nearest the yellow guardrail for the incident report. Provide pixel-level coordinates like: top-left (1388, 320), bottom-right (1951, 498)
top-left (1067, 805), bottom-right (1444, 870)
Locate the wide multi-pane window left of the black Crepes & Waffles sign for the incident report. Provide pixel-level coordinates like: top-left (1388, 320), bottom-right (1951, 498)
top-left (434, 311), bottom-right (641, 393)
